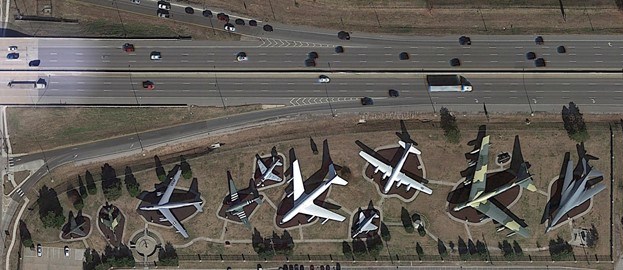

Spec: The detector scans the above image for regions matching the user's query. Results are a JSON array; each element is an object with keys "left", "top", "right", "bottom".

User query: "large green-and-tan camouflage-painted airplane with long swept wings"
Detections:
[{"left": 454, "top": 135, "right": 536, "bottom": 237}]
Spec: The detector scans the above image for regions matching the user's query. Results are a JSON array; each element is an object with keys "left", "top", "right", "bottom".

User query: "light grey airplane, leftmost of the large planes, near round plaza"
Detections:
[{"left": 140, "top": 165, "right": 203, "bottom": 238}]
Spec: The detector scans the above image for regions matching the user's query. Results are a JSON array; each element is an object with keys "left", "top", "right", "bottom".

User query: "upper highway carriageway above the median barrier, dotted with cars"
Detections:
[{"left": 0, "top": 36, "right": 623, "bottom": 71}]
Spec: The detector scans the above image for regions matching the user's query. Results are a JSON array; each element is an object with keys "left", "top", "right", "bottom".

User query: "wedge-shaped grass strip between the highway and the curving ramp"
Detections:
[{"left": 7, "top": 105, "right": 260, "bottom": 153}]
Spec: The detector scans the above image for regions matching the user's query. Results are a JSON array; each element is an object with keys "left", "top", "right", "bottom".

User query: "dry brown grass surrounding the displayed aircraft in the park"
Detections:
[{"left": 15, "top": 112, "right": 623, "bottom": 266}]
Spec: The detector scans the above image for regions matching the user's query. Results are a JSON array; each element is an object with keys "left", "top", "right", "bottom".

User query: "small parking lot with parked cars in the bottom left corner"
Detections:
[{"left": 22, "top": 245, "right": 84, "bottom": 270}]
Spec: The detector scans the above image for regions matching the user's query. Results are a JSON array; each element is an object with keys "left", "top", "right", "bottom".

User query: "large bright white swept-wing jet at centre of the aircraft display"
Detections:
[{"left": 281, "top": 140, "right": 348, "bottom": 224}]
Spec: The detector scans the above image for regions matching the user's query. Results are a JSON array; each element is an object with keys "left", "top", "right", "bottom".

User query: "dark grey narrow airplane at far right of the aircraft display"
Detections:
[{"left": 541, "top": 143, "right": 606, "bottom": 233}]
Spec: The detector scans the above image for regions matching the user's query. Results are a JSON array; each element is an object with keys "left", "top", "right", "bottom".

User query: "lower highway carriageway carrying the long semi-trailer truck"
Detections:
[{"left": 0, "top": 72, "right": 623, "bottom": 106}]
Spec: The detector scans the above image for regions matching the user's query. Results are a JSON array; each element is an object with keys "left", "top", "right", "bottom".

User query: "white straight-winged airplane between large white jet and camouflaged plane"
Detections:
[{"left": 357, "top": 121, "right": 433, "bottom": 194}]
